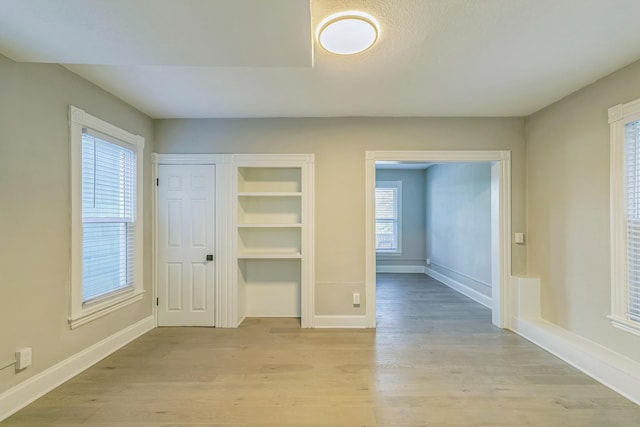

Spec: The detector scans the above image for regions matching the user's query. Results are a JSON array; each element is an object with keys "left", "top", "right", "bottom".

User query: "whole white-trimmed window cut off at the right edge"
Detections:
[{"left": 609, "top": 100, "right": 640, "bottom": 335}]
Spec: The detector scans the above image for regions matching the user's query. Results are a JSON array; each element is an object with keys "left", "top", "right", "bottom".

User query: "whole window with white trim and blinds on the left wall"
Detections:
[{"left": 70, "top": 107, "right": 144, "bottom": 328}]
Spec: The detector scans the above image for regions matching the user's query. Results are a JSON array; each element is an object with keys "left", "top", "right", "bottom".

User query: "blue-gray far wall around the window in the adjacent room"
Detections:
[{"left": 376, "top": 169, "right": 426, "bottom": 267}]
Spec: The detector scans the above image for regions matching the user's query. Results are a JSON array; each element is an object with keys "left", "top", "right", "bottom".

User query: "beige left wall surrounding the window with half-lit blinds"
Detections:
[{"left": 0, "top": 56, "right": 153, "bottom": 393}]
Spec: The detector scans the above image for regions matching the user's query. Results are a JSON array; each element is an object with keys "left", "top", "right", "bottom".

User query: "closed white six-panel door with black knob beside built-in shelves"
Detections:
[{"left": 157, "top": 165, "right": 215, "bottom": 326}]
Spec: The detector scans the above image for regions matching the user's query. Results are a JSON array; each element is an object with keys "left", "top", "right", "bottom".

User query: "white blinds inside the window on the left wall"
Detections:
[{"left": 82, "top": 129, "right": 136, "bottom": 303}]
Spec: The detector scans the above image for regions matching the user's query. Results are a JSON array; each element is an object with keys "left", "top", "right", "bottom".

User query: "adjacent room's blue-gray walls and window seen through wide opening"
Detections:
[{"left": 376, "top": 161, "right": 500, "bottom": 317}]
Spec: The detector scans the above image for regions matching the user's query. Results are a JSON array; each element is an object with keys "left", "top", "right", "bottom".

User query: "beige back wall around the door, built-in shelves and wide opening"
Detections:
[{"left": 154, "top": 118, "right": 525, "bottom": 315}]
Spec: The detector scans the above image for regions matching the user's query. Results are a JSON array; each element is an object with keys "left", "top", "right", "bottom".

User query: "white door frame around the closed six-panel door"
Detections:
[{"left": 151, "top": 153, "right": 230, "bottom": 327}]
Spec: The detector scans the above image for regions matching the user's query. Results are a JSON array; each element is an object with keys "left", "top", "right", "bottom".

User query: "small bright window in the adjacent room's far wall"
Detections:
[{"left": 376, "top": 181, "right": 402, "bottom": 255}]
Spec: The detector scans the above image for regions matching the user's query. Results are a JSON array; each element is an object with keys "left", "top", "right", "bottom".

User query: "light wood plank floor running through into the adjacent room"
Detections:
[{"left": 2, "top": 274, "right": 640, "bottom": 427}]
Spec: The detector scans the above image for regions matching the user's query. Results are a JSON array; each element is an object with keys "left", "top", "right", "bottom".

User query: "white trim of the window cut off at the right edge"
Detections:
[{"left": 608, "top": 99, "right": 640, "bottom": 335}]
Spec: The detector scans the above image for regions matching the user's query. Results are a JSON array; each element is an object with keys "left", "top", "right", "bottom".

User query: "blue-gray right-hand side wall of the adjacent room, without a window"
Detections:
[{"left": 426, "top": 163, "right": 491, "bottom": 297}]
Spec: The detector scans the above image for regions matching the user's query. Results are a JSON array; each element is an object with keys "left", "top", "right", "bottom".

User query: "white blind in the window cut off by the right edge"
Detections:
[{"left": 624, "top": 121, "right": 640, "bottom": 322}]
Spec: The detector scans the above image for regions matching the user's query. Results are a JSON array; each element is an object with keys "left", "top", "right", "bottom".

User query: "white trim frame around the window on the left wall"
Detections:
[{"left": 68, "top": 105, "right": 145, "bottom": 329}]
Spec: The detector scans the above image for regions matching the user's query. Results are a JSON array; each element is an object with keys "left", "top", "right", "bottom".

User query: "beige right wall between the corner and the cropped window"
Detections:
[{"left": 514, "top": 58, "right": 640, "bottom": 361}]
